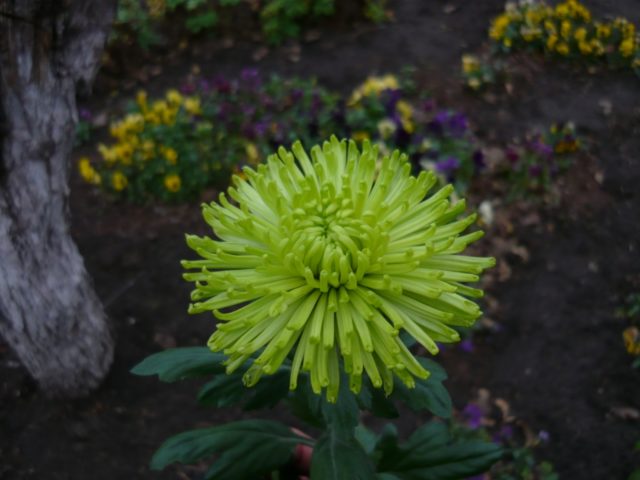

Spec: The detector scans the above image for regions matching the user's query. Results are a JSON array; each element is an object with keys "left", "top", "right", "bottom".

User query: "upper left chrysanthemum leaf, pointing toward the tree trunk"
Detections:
[{"left": 131, "top": 347, "right": 225, "bottom": 382}]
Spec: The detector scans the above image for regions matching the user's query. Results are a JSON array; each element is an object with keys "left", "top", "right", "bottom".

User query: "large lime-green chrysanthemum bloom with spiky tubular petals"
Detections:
[{"left": 183, "top": 137, "right": 495, "bottom": 401}]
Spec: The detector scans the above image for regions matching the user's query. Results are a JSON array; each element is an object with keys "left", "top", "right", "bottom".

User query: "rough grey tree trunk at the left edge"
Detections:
[{"left": 0, "top": 0, "right": 115, "bottom": 396}]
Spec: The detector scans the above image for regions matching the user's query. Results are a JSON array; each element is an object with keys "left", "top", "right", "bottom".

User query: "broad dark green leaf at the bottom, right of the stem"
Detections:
[{"left": 376, "top": 422, "right": 502, "bottom": 480}]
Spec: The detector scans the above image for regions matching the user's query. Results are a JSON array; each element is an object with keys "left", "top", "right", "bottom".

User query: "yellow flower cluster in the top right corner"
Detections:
[{"left": 489, "top": 0, "right": 640, "bottom": 74}]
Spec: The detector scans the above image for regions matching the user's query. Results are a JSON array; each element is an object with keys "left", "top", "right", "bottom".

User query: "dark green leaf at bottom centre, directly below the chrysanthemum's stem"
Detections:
[{"left": 311, "top": 426, "right": 375, "bottom": 480}]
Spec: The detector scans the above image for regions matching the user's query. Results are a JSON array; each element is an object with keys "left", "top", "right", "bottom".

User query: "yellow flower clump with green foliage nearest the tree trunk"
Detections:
[{"left": 79, "top": 90, "right": 219, "bottom": 201}]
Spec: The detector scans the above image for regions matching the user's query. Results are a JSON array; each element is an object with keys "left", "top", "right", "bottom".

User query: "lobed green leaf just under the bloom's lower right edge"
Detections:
[{"left": 391, "top": 358, "right": 452, "bottom": 418}]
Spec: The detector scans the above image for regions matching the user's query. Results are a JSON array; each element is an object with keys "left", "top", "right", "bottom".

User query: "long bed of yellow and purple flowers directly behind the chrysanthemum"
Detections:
[{"left": 80, "top": 69, "right": 482, "bottom": 201}]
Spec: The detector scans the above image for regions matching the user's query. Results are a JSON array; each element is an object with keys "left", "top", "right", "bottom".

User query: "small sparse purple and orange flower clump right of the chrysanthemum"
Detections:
[{"left": 503, "top": 123, "right": 582, "bottom": 197}]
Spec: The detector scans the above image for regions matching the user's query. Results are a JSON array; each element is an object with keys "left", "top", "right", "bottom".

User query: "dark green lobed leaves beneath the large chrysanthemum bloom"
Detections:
[{"left": 132, "top": 347, "right": 501, "bottom": 480}]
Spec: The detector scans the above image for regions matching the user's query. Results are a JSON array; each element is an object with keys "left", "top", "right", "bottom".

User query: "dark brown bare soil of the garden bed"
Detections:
[{"left": 0, "top": 0, "right": 640, "bottom": 480}]
